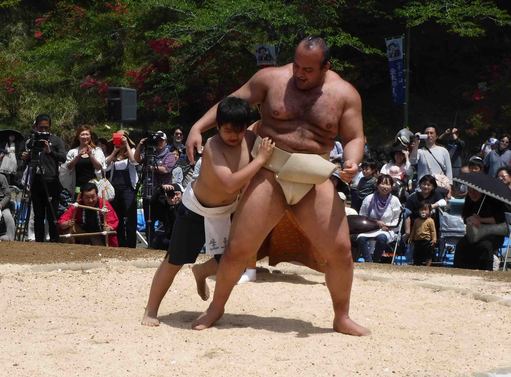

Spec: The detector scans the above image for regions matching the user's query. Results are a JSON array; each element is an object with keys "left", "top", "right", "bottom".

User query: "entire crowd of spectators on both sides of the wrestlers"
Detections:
[{"left": 0, "top": 114, "right": 511, "bottom": 270}]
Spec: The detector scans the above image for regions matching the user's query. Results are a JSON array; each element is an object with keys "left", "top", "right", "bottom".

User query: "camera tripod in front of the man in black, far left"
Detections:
[{"left": 14, "top": 149, "right": 56, "bottom": 241}]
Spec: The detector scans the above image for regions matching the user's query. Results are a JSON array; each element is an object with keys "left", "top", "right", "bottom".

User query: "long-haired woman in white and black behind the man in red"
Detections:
[{"left": 61, "top": 125, "right": 106, "bottom": 197}]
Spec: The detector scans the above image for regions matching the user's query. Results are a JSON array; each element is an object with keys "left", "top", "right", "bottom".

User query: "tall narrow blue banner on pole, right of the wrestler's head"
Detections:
[{"left": 385, "top": 36, "right": 406, "bottom": 105}]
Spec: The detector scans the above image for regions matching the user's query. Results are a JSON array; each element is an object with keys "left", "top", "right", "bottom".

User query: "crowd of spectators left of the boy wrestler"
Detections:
[{"left": 0, "top": 114, "right": 193, "bottom": 248}]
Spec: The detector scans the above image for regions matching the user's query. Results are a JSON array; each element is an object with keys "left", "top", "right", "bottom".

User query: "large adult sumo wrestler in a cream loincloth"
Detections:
[{"left": 186, "top": 37, "right": 370, "bottom": 335}]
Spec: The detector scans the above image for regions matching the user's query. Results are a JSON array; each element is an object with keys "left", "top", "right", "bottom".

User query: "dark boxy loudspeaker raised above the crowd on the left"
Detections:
[{"left": 107, "top": 87, "right": 137, "bottom": 122}]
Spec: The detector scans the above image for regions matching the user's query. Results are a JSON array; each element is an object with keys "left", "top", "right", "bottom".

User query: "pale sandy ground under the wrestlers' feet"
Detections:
[{"left": 0, "top": 242, "right": 511, "bottom": 377}]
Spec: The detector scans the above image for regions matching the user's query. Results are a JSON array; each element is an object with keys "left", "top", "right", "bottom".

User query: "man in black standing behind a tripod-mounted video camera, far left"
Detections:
[{"left": 21, "top": 114, "right": 66, "bottom": 242}]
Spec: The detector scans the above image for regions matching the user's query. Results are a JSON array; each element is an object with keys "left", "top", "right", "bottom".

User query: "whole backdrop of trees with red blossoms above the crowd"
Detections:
[{"left": 0, "top": 0, "right": 511, "bottom": 148}]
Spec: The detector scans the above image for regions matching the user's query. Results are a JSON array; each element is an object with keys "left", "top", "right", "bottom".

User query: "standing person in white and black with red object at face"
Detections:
[{"left": 106, "top": 130, "right": 138, "bottom": 248}]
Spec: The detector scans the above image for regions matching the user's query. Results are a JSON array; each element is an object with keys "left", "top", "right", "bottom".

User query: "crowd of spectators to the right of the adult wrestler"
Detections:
[{"left": 330, "top": 124, "right": 511, "bottom": 270}]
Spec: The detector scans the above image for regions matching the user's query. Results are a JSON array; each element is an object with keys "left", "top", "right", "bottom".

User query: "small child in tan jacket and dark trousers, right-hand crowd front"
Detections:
[{"left": 410, "top": 202, "right": 437, "bottom": 266}]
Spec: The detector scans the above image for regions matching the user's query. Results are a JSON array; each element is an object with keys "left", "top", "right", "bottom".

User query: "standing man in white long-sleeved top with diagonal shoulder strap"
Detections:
[{"left": 410, "top": 124, "right": 452, "bottom": 189}]
